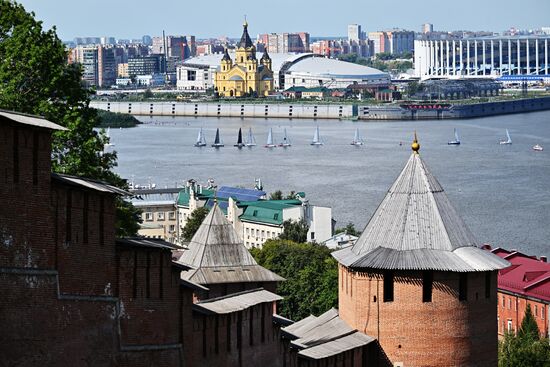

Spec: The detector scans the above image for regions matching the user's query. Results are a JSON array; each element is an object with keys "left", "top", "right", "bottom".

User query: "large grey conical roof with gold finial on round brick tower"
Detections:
[{"left": 333, "top": 140, "right": 509, "bottom": 272}]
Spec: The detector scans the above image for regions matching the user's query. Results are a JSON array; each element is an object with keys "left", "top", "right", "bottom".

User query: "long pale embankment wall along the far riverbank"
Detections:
[{"left": 90, "top": 97, "right": 550, "bottom": 120}]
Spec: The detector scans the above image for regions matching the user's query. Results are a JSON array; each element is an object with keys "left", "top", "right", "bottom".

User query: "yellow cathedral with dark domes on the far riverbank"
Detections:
[{"left": 214, "top": 21, "right": 273, "bottom": 97}]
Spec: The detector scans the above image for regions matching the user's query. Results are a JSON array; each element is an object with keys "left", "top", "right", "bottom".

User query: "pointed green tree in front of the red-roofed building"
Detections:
[{"left": 498, "top": 305, "right": 550, "bottom": 367}]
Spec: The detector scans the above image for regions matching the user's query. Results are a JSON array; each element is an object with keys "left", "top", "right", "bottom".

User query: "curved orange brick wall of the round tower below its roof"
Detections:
[{"left": 339, "top": 266, "right": 497, "bottom": 367}]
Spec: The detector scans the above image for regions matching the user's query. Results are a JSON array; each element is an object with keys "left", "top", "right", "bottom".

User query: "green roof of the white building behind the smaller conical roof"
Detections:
[{"left": 239, "top": 200, "right": 302, "bottom": 225}]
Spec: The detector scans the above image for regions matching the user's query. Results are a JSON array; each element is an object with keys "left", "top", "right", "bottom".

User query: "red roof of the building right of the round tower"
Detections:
[{"left": 484, "top": 245, "right": 550, "bottom": 302}]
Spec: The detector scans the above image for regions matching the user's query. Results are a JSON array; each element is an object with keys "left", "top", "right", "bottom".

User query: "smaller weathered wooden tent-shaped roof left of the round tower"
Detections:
[{"left": 177, "top": 203, "right": 284, "bottom": 284}]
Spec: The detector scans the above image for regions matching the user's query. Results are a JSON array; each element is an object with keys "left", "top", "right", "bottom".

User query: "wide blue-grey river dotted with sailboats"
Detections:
[{"left": 106, "top": 111, "right": 550, "bottom": 256}]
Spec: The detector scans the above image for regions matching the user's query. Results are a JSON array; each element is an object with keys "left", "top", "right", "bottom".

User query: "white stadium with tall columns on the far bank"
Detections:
[{"left": 414, "top": 35, "right": 550, "bottom": 79}]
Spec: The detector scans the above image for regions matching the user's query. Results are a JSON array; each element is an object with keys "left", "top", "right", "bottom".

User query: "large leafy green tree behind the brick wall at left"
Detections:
[{"left": 0, "top": 0, "right": 139, "bottom": 235}]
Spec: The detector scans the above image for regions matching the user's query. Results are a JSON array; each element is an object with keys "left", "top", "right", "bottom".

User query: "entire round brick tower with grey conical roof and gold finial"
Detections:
[{"left": 333, "top": 138, "right": 509, "bottom": 367}]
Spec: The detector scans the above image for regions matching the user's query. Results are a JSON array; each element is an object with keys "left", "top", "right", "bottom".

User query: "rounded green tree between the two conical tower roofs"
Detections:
[{"left": 251, "top": 240, "right": 338, "bottom": 320}]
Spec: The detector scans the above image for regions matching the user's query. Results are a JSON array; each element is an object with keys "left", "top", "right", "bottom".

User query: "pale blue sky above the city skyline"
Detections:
[{"left": 18, "top": 0, "right": 550, "bottom": 40}]
